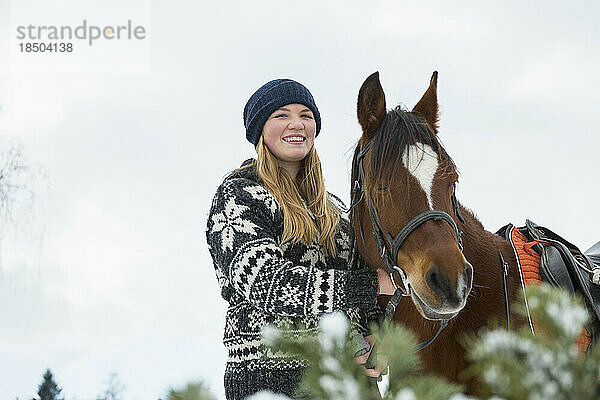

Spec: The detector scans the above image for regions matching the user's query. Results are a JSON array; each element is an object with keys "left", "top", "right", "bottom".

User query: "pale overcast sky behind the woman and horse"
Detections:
[{"left": 0, "top": 0, "right": 600, "bottom": 400}]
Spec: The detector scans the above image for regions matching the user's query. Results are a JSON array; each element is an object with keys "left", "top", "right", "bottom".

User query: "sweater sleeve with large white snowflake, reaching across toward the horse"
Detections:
[{"left": 206, "top": 178, "right": 377, "bottom": 317}]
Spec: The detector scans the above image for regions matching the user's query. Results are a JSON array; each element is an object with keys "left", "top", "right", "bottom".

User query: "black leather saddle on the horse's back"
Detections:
[{"left": 496, "top": 220, "right": 600, "bottom": 343}]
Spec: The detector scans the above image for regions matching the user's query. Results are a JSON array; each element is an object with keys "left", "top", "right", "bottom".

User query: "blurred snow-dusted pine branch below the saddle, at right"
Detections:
[{"left": 467, "top": 285, "right": 600, "bottom": 400}]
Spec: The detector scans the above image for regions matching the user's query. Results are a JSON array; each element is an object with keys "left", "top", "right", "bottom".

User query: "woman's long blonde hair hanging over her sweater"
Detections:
[{"left": 234, "top": 135, "right": 340, "bottom": 257}]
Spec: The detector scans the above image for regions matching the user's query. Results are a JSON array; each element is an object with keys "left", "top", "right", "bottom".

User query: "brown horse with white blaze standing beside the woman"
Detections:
[{"left": 350, "top": 72, "right": 596, "bottom": 393}]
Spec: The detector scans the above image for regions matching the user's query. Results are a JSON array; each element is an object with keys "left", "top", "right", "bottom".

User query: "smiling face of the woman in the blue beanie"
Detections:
[{"left": 262, "top": 104, "right": 316, "bottom": 166}]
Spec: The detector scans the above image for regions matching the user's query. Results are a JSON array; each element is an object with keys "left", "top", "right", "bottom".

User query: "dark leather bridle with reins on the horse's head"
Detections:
[{"left": 350, "top": 141, "right": 465, "bottom": 360}]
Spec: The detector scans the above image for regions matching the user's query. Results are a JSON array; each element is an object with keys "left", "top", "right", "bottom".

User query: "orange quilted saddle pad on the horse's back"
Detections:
[{"left": 511, "top": 228, "right": 592, "bottom": 352}]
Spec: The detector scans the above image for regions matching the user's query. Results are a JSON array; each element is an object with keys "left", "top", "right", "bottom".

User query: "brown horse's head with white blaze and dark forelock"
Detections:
[{"left": 352, "top": 72, "right": 473, "bottom": 320}]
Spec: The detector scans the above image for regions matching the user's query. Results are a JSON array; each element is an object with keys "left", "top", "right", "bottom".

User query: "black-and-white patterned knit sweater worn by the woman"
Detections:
[{"left": 206, "top": 160, "right": 381, "bottom": 400}]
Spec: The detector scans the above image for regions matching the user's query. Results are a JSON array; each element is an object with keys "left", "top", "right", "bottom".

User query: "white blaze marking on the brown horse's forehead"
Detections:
[{"left": 402, "top": 143, "right": 438, "bottom": 210}]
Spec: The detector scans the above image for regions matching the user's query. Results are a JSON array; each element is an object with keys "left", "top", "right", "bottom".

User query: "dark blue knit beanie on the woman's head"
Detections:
[{"left": 244, "top": 79, "right": 321, "bottom": 146}]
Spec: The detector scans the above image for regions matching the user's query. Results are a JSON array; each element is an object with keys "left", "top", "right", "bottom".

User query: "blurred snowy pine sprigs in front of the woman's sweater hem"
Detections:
[{"left": 252, "top": 312, "right": 464, "bottom": 400}]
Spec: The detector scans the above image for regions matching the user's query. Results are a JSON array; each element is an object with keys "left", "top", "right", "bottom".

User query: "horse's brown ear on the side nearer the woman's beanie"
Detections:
[{"left": 356, "top": 72, "right": 386, "bottom": 141}]
